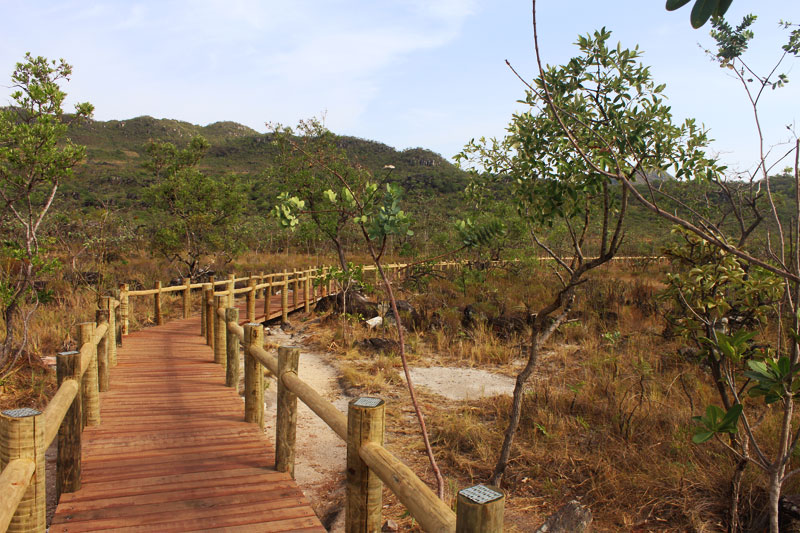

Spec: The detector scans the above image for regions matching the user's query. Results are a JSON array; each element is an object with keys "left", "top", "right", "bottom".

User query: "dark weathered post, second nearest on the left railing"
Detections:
[{"left": 56, "top": 352, "right": 83, "bottom": 494}]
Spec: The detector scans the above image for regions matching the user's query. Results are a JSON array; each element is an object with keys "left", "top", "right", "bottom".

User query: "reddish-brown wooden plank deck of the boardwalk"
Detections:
[{"left": 49, "top": 295, "right": 325, "bottom": 533}]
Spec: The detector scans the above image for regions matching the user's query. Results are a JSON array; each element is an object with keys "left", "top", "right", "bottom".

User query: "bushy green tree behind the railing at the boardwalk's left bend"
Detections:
[{"left": 147, "top": 137, "right": 245, "bottom": 277}]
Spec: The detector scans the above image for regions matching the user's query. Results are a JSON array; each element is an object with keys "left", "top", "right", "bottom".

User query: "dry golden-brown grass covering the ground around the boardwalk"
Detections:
[{"left": 0, "top": 255, "right": 798, "bottom": 531}]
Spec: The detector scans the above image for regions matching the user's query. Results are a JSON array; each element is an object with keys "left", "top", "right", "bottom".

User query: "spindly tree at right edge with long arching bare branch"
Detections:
[{"left": 533, "top": 4, "right": 800, "bottom": 533}]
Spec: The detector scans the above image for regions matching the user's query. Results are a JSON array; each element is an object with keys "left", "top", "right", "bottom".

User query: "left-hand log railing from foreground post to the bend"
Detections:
[{"left": 0, "top": 297, "right": 119, "bottom": 533}]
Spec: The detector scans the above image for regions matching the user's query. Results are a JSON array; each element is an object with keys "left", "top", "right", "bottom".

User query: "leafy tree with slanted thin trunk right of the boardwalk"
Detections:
[{"left": 458, "top": 23, "right": 714, "bottom": 483}]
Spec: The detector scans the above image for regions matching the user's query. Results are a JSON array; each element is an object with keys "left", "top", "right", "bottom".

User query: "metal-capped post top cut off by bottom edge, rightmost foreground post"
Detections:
[{"left": 456, "top": 485, "right": 506, "bottom": 533}]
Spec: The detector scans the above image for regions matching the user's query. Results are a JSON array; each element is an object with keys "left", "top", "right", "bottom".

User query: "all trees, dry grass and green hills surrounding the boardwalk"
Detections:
[{"left": 0, "top": 6, "right": 800, "bottom": 532}]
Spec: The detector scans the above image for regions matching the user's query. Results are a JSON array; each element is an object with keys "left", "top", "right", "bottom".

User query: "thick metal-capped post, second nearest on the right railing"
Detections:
[{"left": 345, "top": 397, "right": 385, "bottom": 533}]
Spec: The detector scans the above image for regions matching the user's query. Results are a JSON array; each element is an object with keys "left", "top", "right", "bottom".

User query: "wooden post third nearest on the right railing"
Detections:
[{"left": 275, "top": 346, "right": 300, "bottom": 479}]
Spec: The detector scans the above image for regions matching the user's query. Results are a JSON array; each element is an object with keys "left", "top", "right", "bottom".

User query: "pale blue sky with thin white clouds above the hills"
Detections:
[{"left": 0, "top": 0, "right": 800, "bottom": 174}]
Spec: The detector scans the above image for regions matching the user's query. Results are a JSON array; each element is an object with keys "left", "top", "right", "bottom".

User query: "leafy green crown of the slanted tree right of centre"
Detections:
[{"left": 457, "top": 29, "right": 722, "bottom": 237}]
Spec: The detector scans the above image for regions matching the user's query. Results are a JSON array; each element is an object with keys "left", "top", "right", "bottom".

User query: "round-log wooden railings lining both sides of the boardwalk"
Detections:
[{"left": 0, "top": 262, "right": 504, "bottom": 533}]
